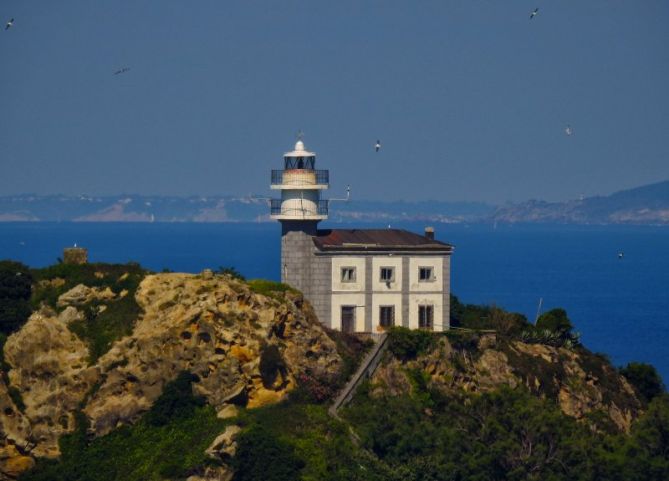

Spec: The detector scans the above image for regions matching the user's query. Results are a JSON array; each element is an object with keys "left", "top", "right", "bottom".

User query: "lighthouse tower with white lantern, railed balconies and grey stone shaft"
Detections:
[{"left": 270, "top": 140, "right": 329, "bottom": 288}]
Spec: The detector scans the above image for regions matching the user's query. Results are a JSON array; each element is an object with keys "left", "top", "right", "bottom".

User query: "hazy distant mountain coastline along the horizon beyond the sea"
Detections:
[{"left": 0, "top": 181, "right": 669, "bottom": 225}]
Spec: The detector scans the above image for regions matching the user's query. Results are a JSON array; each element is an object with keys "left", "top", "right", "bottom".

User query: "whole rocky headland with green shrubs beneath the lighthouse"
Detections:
[{"left": 0, "top": 265, "right": 669, "bottom": 481}]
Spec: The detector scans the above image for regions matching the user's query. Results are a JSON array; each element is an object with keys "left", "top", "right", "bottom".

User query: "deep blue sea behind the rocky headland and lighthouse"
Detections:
[{"left": 0, "top": 223, "right": 669, "bottom": 382}]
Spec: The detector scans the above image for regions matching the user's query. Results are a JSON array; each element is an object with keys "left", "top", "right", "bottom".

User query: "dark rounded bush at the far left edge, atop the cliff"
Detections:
[{"left": 0, "top": 261, "right": 33, "bottom": 334}]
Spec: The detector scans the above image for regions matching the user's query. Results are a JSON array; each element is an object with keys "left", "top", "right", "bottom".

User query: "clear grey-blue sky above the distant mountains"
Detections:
[{"left": 0, "top": 0, "right": 669, "bottom": 203}]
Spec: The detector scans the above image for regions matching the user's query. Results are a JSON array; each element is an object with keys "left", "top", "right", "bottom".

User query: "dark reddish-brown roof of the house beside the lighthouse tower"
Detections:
[{"left": 313, "top": 229, "right": 453, "bottom": 252}]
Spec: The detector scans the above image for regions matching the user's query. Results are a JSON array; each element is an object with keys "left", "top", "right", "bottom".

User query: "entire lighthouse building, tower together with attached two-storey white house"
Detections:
[{"left": 271, "top": 141, "right": 453, "bottom": 332}]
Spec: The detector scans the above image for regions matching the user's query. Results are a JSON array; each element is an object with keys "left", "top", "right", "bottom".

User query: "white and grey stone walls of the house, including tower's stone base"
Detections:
[{"left": 281, "top": 227, "right": 450, "bottom": 332}]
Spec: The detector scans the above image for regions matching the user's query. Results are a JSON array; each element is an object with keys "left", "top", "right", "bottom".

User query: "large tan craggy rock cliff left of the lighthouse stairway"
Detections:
[{"left": 0, "top": 273, "right": 342, "bottom": 479}]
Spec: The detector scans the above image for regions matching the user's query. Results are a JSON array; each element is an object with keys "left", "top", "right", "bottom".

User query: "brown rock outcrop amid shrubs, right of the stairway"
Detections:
[{"left": 372, "top": 337, "right": 641, "bottom": 431}]
